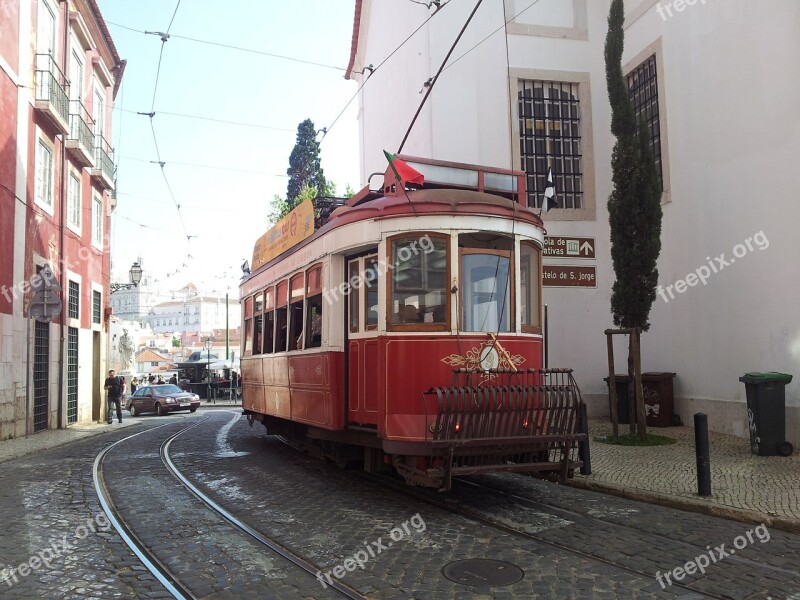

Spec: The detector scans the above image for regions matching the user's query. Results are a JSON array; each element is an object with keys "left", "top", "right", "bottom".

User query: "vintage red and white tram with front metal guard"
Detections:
[{"left": 240, "top": 156, "right": 586, "bottom": 489}]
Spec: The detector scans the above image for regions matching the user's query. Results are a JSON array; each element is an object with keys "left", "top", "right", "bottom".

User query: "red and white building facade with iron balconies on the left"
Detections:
[{"left": 0, "top": 0, "right": 125, "bottom": 440}]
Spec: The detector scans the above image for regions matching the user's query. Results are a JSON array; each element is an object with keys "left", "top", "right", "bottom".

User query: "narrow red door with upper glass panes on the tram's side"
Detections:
[{"left": 347, "top": 254, "right": 379, "bottom": 425}]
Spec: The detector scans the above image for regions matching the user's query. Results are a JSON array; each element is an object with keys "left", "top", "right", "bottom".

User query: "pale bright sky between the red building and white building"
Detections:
[{"left": 98, "top": 0, "right": 361, "bottom": 297}]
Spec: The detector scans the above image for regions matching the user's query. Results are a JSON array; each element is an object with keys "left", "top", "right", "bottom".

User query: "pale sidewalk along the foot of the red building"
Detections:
[{"left": 0, "top": 400, "right": 242, "bottom": 463}]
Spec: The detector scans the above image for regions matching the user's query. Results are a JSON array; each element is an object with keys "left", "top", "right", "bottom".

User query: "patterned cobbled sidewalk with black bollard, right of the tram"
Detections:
[{"left": 568, "top": 419, "right": 800, "bottom": 533}]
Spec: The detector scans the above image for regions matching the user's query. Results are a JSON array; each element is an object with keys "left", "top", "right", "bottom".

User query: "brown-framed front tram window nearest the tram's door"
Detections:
[{"left": 389, "top": 234, "right": 450, "bottom": 331}]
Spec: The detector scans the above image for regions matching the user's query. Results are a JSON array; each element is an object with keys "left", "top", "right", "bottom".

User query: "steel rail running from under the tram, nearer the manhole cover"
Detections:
[{"left": 366, "top": 473, "right": 730, "bottom": 600}]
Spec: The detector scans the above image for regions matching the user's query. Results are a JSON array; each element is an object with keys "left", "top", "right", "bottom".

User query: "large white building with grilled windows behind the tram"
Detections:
[{"left": 348, "top": 0, "right": 800, "bottom": 445}]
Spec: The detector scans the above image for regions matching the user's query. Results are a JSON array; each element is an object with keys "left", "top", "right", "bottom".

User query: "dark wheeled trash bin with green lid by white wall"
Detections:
[{"left": 739, "top": 373, "right": 794, "bottom": 456}]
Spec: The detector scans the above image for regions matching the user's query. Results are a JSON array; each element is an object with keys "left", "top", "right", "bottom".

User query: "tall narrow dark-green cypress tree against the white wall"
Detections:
[{"left": 605, "top": 0, "right": 661, "bottom": 437}]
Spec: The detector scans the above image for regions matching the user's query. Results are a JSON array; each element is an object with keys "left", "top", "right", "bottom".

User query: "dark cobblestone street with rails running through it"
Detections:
[{"left": 0, "top": 409, "right": 800, "bottom": 600}]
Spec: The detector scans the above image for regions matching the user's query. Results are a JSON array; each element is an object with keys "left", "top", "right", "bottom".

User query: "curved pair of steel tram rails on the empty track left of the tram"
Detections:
[{"left": 93, "top": 417, "right": 366, "bottom": 600}]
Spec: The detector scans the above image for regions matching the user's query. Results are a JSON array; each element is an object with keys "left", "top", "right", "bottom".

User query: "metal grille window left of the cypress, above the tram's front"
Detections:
[{"left": 517, "top": 80, "right": 583, "bottom": 208}]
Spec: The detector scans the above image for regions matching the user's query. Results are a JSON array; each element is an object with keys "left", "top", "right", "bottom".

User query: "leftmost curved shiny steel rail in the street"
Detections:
[{"left": 92, "top": 417, "right": 200, "bottom": 600}]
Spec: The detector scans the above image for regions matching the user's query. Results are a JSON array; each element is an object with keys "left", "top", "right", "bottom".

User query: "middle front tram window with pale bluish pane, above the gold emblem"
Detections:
[{"left": 459, "top": 248, "right": 513, "bottom": 333}]
